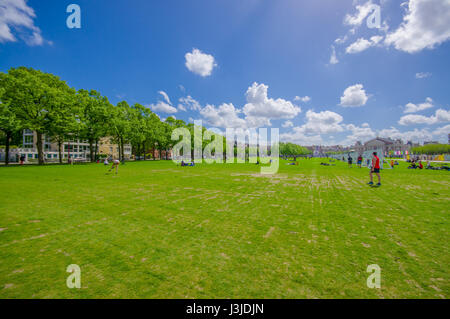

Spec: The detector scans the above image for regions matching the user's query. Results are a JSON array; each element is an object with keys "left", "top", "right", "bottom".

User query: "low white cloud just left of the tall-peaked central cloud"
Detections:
[{"left": 200, "top": 103, "right": 247, "bottom": 128}]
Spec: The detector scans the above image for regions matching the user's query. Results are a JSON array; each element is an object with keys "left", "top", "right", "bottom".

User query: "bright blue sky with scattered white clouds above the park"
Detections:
[{"left": 0, "top": 0, "right": 450, "bottom": 145}]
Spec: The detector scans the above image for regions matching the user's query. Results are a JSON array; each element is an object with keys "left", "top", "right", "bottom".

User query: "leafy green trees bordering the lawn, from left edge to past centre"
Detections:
[{"left": 0, "top": 67, "right": 309, "bottom": 164}]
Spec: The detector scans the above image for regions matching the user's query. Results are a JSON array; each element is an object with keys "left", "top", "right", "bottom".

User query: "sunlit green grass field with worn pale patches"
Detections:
[{"left": 0, "top": 160, "right": 450, "bottom": 298}]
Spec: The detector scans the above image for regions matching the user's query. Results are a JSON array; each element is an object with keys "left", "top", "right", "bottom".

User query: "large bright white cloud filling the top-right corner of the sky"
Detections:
[{"left": 385, "top": 0, "right": 450, "bottom": 53}]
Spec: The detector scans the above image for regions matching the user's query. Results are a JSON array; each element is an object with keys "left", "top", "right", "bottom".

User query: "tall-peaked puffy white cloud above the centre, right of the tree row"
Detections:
[{"left": 243, "top": 82, "right": 301, "bottom": 127}]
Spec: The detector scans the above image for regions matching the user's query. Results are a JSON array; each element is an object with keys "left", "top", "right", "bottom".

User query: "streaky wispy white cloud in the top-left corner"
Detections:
[{"left": 0, "top": 0, "right": 44, "bottom": 45}]
